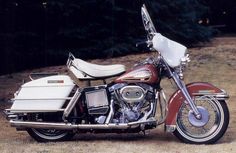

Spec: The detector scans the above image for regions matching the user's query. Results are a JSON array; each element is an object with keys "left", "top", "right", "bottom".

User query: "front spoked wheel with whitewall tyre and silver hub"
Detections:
[{"left": 174, "top": 96, "right": 229, "bottom": 144}]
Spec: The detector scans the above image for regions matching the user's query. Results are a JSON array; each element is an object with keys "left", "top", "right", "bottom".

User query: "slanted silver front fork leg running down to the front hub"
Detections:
[{"left": 172, "top": 72, "right": 202, "bottom": 119}]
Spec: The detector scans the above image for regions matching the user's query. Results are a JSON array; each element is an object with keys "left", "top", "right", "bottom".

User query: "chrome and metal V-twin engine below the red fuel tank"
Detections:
[{"left": 111, "top": 83, "right": 154, "bottom": 123}]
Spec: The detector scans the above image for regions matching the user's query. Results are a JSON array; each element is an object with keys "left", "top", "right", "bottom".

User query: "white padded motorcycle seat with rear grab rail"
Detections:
[{"left": 70, "top": 58, "right": 125, "bottom": 79}]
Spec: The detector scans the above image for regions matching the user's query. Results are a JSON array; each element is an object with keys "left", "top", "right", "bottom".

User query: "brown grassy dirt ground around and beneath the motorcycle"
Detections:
[{"left": 0, "top": 37, "right": 236, "bottom": 153}]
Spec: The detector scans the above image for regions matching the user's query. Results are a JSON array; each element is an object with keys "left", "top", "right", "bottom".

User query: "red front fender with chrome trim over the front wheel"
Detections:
[{"left": 165, "top": 82, "right": 229, "bottom": 132}]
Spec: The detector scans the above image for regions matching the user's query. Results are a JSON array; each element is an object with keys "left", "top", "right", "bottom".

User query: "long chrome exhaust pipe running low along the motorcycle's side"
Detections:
[{"left": 10, "top": 119, "right": 156, "bottom": 130}]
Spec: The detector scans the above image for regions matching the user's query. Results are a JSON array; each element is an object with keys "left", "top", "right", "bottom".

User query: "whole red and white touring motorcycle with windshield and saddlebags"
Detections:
[{"left": 5, "top": 5, "right": 229, "bottom": 144}]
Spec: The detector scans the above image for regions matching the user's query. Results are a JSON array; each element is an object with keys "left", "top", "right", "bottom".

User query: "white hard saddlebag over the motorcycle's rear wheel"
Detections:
[{"left": 11, "top": 75, "right": 75, "bottom": 111}]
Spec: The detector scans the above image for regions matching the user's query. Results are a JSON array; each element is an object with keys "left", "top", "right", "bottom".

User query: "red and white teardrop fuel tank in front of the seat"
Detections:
[{"left": 115, "top": 64, "right": 159, "bottom": 84}]
